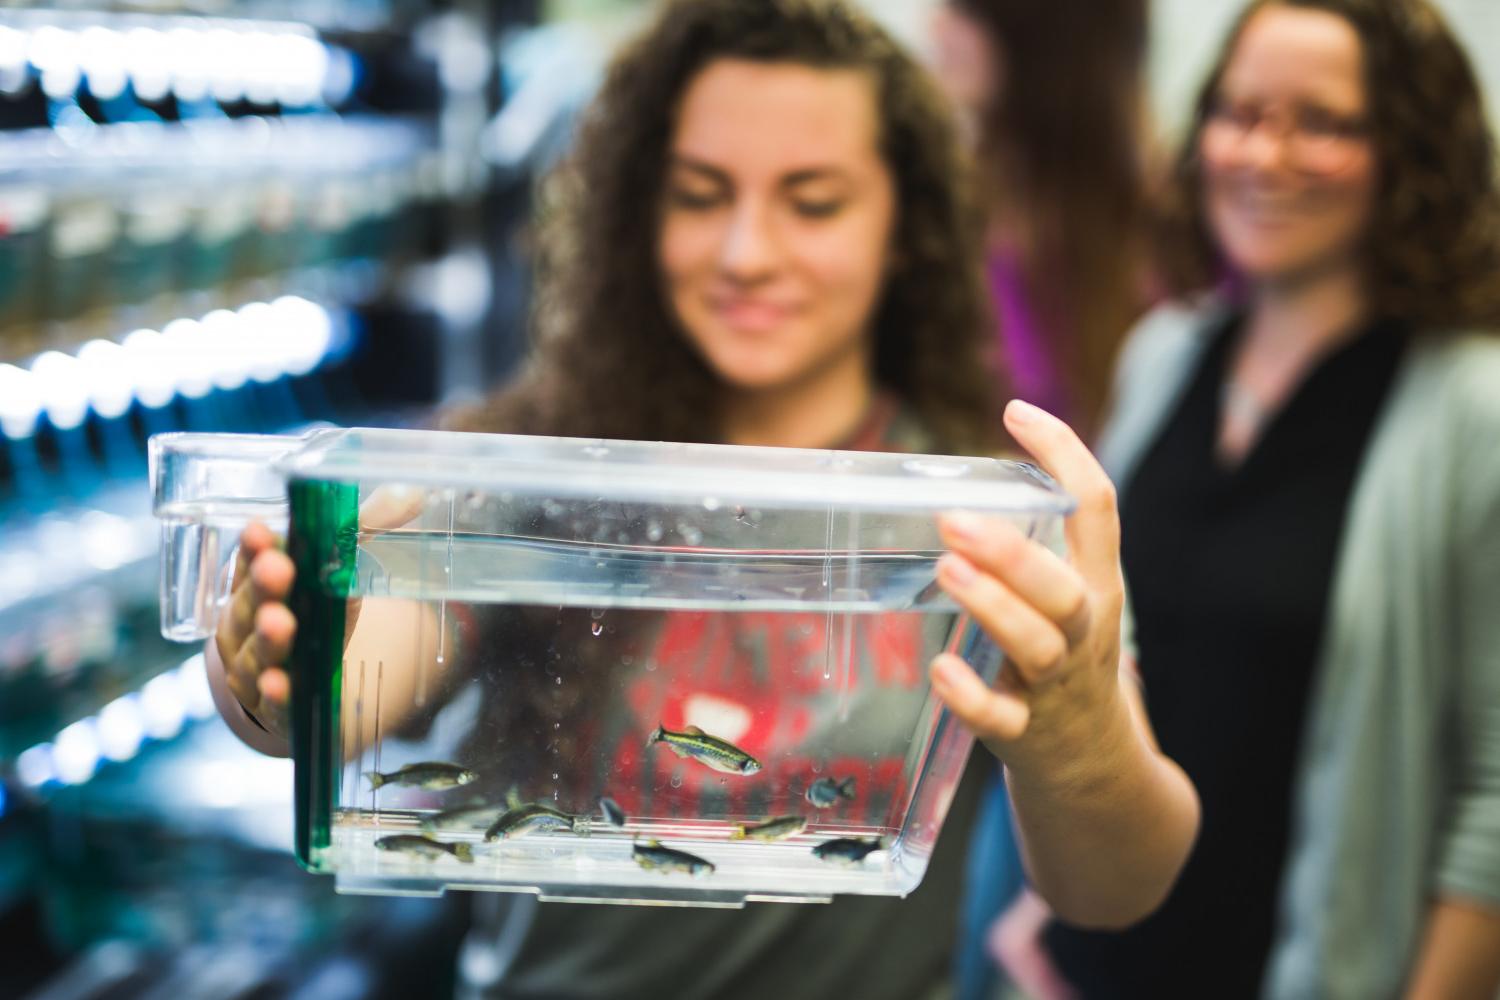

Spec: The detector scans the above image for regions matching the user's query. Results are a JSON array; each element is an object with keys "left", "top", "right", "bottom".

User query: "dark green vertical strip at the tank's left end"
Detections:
[{"left": 287, "top": 480, "right": 360, "bottom": 871}]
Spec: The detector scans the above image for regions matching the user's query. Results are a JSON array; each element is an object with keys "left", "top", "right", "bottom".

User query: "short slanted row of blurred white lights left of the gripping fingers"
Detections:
[{"left": 15, "top": 652, "right": 215, "bottom": 789}]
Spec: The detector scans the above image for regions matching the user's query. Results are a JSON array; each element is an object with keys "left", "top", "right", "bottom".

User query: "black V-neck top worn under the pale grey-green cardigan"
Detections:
[{"left": 1046, "top": 321, "right": 1406, "bottom": 997}]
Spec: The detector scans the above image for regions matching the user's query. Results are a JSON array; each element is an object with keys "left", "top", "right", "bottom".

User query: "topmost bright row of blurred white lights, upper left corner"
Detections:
[{"left": 0, "top": 21, "right": 357, "bottom": 108}]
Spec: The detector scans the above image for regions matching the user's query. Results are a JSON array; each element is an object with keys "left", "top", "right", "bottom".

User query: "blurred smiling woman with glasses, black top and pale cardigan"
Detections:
[{"left": 1026, "top": 0, "right": 1500, "bottom": 999}]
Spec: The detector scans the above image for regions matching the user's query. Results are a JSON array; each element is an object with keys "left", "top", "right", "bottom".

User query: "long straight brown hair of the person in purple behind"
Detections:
[{"left": 950, "top": 0, "right": 1148, "bottom": 432}]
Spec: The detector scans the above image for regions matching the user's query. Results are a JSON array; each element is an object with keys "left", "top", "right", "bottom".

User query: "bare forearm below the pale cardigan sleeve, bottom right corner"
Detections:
[{"left": 1406, "top": 900, "right": 1500, "bottom": 1000}]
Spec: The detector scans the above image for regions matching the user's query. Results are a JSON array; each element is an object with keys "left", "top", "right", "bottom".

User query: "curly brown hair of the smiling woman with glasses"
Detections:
[{"left": 1161, "top": 0, "right": 1500, "bottom": 330}]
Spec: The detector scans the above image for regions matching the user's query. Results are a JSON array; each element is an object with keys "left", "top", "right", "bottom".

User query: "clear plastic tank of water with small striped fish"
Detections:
[{"left": 152, "top": 429, "right": 1071, "bottom": 907}]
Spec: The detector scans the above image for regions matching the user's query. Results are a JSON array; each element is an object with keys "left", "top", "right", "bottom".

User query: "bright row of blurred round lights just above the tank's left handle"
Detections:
[{"left": 0, "top": 295, "right": 336, "bottom": 441}]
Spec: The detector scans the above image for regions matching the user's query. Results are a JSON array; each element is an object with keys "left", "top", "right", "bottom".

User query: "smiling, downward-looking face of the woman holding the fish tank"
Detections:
[{"left": 657, "top": 58, "right": 896, "bottom": 391}]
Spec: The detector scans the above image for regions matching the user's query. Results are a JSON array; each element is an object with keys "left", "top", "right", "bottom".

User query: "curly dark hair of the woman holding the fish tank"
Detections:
[{"left": 449, "top": 0, "right": 1005, "bottom": 451}]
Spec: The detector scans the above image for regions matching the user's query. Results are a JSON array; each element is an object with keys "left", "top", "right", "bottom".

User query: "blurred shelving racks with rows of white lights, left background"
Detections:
[{"left": 0, "top": 0, "right": 612, "bottom": 1000}]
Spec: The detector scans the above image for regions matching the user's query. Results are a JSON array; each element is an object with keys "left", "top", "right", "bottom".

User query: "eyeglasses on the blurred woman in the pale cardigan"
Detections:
[{"left": 1200, "top": 100, "right": 1370, "bottom": 174}]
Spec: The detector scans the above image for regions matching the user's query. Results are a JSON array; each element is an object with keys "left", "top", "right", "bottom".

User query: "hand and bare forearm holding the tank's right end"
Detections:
[{"left": 932, "top": 402, "right": 1199, "bottom": 928}]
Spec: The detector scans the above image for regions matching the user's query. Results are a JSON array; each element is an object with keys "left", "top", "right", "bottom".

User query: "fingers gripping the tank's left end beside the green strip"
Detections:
[{"left": 215, "top": 522, "right": 297, "bottom": 736}]
